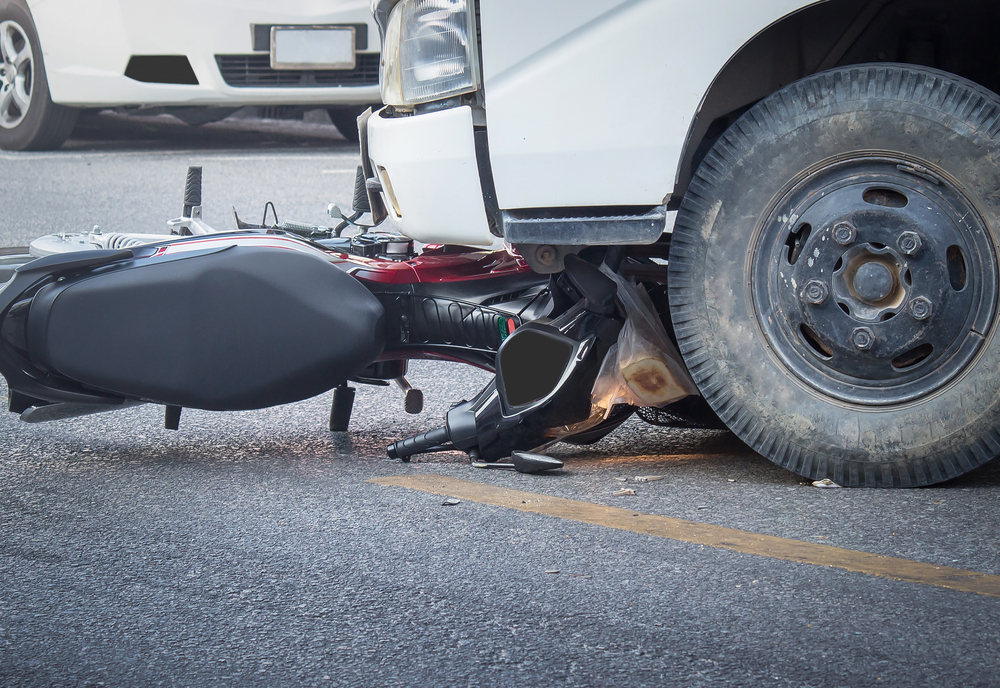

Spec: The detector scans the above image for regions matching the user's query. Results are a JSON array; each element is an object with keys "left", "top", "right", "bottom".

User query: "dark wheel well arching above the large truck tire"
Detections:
[{"left": 670, "top": 0, "right": 1000, "bottom": 207}]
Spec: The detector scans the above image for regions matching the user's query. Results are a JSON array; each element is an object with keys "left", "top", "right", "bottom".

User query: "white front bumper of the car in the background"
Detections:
[{"left": 28, "top": 0, "right": 381, "bottom": 107}]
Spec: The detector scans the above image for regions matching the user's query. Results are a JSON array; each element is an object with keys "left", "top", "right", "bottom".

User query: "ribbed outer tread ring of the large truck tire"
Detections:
[{"left": 668, "top": 64, "right": 1000, "bottom": 487}]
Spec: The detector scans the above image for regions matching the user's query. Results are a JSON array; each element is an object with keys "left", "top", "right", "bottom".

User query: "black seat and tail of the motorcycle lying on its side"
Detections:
[{"left": 0, "top": 242, "right": 385, "bottom": 410}]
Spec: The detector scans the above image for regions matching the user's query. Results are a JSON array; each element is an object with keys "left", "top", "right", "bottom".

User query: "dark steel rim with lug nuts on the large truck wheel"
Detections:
[{"left": 750, "top": 154, "right": 998, "bottom": 406}]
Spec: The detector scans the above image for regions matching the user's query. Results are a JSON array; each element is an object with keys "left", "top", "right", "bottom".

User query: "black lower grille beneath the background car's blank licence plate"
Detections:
[{"left": 215, "top": 53, "right": 379, "bottom": 88}]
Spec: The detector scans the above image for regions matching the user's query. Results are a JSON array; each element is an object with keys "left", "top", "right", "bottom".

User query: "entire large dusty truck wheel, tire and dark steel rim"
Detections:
[{"left": 668, "top": 64, "right": 1000, "bottom": 487}]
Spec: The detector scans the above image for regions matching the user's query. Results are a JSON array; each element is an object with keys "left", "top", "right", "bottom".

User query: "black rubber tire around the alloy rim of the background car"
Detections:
[{"left": 0, "top": 0, "right": 78, "bottom": 151}]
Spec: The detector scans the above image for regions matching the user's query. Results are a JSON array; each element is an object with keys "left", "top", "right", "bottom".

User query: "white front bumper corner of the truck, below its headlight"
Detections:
[{"left": 368, "top": 106, "right": 500, "bottom": 246}]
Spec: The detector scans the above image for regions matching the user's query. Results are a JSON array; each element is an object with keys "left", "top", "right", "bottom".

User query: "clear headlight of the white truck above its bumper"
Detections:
[{"left": 379, "top": 0, "right": 479, "bottom": 106}]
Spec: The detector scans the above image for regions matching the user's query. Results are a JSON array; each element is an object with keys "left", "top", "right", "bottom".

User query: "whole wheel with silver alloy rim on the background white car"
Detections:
[{"left": 0, "top": 0, "right": 77, "bottom": 151}]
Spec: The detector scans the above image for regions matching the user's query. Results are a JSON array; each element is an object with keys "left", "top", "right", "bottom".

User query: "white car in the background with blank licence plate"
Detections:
[{"left": 0, "top": 0, "right": 380, "bottom": 150}]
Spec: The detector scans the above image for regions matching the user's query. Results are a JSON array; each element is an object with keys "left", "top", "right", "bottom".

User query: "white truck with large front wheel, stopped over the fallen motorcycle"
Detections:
[{"left": 362, "top": 0, "right": 1000, "bottom": 486}]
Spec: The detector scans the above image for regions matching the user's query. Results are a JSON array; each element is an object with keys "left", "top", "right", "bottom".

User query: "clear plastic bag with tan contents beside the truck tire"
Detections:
[{"left": 591, "top": 266, "right": 698, "bottom": 418}]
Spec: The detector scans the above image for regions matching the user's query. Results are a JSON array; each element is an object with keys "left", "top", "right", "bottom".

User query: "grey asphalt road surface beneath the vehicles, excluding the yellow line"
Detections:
[{"left": 0, "top": 119, "right": 1000, "bottom": 686}]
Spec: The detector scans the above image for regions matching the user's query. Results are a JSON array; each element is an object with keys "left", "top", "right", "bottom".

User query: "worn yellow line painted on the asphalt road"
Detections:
[{"left": 370, "top": 475, "right": 1000, "bottom": 597}]
